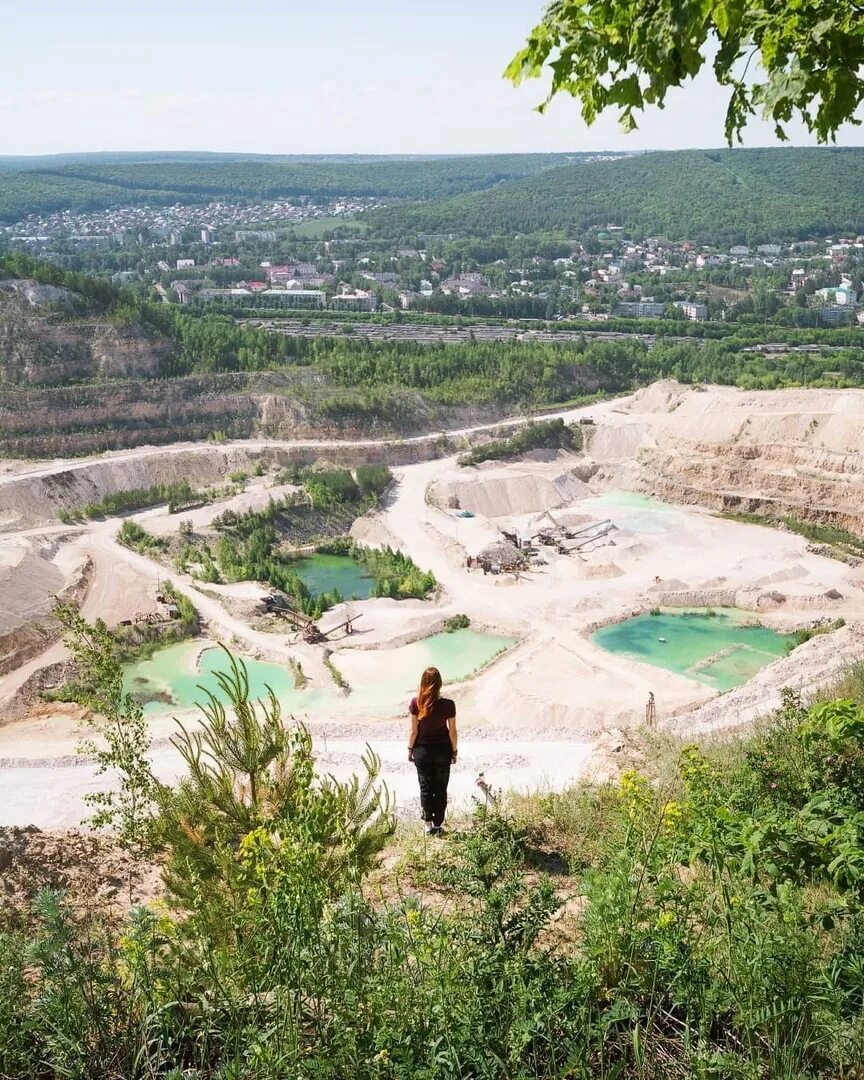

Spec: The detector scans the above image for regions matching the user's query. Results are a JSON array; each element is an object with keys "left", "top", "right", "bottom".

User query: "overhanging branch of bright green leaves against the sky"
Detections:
[{"left": 505, "top": 0, "right": 864, "bottom": 144}]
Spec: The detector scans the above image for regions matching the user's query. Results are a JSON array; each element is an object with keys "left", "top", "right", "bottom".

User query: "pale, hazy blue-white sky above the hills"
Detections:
[{"left": 6, "top": 0, "right": 864, "bottom": 156}]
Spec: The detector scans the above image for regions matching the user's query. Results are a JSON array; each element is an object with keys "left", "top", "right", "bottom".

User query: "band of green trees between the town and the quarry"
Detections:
[{"left": 0, "top": 255, "right": 864, "bottom": 414}]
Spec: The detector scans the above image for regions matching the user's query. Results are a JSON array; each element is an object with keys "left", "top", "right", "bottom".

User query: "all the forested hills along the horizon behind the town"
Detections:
[{"left": 0, "top": 147, "right": 864, "bottom": 244}]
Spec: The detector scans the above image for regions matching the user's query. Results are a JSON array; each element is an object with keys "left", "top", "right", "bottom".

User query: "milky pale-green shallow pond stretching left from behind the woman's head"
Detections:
[{"left": 124, "top": 630, "right": 515, "bottom": 715}]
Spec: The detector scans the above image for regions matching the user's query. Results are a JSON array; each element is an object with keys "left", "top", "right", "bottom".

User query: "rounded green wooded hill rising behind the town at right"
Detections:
[{"left": 369, "top": 148, "right": 864, "bottom": 243}]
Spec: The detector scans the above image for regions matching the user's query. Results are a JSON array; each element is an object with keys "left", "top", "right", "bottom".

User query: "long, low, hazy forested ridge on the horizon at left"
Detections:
[{"left": 0, "top": 152, "right": 596, "bottom": 222}]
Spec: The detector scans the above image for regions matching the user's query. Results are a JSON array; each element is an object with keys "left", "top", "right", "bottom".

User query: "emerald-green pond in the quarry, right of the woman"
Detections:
[{"left": 592, "top": 611, "right": 788, "bottom": 690}]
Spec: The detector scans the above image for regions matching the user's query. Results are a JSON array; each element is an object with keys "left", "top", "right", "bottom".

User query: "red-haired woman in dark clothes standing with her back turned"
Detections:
[{"left": 408, "top": 667, "right": 459, "bottom": 836}]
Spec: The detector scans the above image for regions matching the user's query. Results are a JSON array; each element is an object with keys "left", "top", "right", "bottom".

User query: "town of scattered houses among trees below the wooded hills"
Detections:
[{"left": 0, "top": 197, "right": 864, "bottom": 327}]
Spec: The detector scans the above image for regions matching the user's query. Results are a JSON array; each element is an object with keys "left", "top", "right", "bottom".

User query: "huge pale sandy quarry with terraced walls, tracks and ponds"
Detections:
[{"left": 0, "top": 381, "right": 864, "bottom": 827}]
